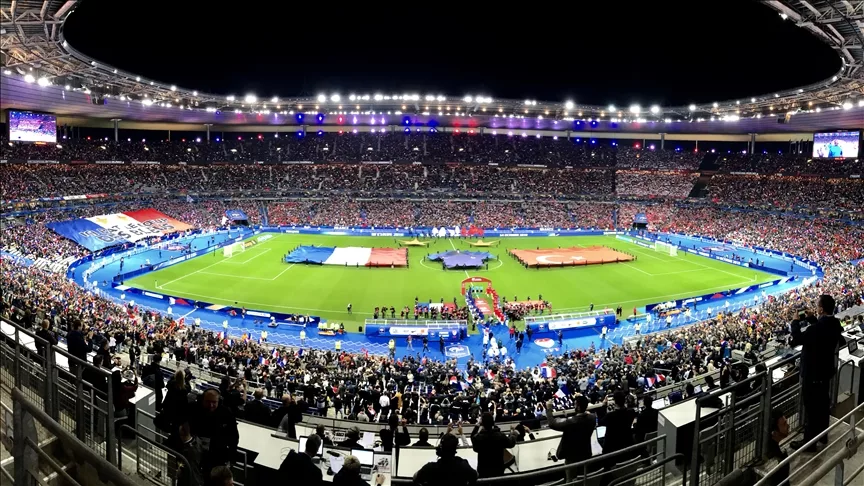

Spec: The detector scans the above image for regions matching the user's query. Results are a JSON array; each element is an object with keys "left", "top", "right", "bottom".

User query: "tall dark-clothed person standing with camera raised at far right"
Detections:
[{"left": 790, "top": 295, "right": 845, "bottom": 452}]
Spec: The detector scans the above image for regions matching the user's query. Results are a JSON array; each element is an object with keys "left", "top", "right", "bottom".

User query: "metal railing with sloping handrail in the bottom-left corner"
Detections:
[{"left": 2, "top": 387, "right": 135, "bottom": 486}]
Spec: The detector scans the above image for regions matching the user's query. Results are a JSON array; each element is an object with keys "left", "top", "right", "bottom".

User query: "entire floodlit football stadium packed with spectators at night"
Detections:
[{"left": 0, "top": 0, "right": 864, "bottom": 486}]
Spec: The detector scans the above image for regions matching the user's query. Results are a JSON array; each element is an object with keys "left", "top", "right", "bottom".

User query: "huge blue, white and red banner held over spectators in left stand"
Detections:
[{"left": 48, "top": 209, "right": 192, "bottom": 251}]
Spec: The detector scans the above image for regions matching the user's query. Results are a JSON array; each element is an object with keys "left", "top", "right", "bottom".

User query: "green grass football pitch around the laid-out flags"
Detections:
[{"left": 126, "top": 234, "right": 777, "bottom": 330}]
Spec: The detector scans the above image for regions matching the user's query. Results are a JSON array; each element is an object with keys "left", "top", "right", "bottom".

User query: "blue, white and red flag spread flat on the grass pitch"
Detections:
[{"left": 285, "top": 245, "right": 408, "bottom": 267}]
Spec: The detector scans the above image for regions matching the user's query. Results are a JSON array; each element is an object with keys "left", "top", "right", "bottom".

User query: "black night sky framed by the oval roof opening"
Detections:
[{"left": 65, "top": 0, "right": 840, "bottom": 106}]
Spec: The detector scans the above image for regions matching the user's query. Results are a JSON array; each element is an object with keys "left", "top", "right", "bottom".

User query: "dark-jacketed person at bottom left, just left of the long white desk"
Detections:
[{"left": 189, "top": 388, "right": 240, "bottom": 474}]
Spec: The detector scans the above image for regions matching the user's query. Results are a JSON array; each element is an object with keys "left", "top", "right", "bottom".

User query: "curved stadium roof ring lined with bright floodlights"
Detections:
[{"left": 0, "top": 0, "right": 864, "bottom": 127}]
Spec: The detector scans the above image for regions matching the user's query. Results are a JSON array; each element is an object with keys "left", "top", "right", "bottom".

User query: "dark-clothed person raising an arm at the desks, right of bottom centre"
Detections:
[{"left": 546, "top": 395, "right": 597, "bottom": 481}]
